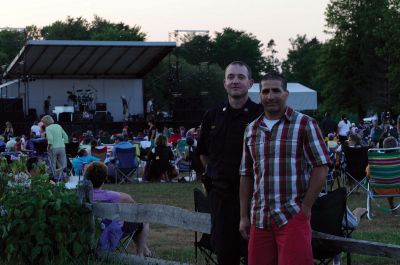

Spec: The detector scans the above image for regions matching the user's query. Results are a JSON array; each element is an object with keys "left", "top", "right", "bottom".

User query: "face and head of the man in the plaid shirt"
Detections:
[{"left": 260, "top": 80, "right": 289, "bottom": 119}]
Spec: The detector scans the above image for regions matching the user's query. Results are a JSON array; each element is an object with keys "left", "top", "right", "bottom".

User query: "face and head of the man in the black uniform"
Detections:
[{"left": 224, "top": 64, "right": 253, "bottom": 99}]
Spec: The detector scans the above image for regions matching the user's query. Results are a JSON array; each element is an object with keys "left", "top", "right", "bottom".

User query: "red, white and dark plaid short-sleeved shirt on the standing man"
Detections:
[{"left": 240, "top": 107, "right": 330, "bottom": 228}]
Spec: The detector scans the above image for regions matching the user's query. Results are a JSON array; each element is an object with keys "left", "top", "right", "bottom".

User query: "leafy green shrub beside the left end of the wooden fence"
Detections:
[{"left": 0, "top": 161, "right": 92, "bottom": 264}]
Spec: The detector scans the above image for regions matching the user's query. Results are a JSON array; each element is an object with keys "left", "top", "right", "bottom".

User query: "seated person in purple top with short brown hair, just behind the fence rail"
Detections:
[{"left": 85, "top": 162, "right": 151, "bottom": 257}]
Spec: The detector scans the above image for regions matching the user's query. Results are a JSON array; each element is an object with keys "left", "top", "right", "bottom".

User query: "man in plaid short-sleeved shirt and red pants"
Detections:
[{"left": 239, "top": 73, "right": 330, "bottom": 265}]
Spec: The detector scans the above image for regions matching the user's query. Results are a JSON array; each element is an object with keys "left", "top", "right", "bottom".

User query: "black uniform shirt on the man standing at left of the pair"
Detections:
[{"left": 198, "top": 99, "right": 262, "bottom": 193}]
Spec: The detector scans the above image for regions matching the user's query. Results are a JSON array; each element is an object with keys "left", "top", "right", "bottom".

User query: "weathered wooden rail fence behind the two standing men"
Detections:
[{"left": 88, "top": 203, "right": 400, "bottom": 265}]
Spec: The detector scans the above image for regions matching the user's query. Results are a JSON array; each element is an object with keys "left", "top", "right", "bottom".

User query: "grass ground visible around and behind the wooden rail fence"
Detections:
[{"left": 105, "top": 182, "right": 400, "bottom": 265}]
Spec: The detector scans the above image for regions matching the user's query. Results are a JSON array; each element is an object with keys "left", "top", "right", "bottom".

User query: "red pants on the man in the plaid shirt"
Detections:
[{"left": 248, "top": 211, "right": 313, "bottom": 265}]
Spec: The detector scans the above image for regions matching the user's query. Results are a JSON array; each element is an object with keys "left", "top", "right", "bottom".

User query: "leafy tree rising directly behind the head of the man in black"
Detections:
[{"left": 212, "top": 27, "right": 268, "bottom": 80}]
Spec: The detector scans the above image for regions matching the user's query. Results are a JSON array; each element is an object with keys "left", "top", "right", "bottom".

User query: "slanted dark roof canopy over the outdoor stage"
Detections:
[{"left": 4, "top": 40, "right": 176, "bottom": 79}]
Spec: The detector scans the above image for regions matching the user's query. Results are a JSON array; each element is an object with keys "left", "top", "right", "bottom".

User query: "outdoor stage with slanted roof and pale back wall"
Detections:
[{"left": 0, "top": 40, "right": 176, "bottom": 122}]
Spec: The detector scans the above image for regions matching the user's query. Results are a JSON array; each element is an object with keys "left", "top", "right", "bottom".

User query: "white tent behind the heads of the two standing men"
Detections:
[{"left": 249, "top": 83, "right": 317, "bottom": 110}]
